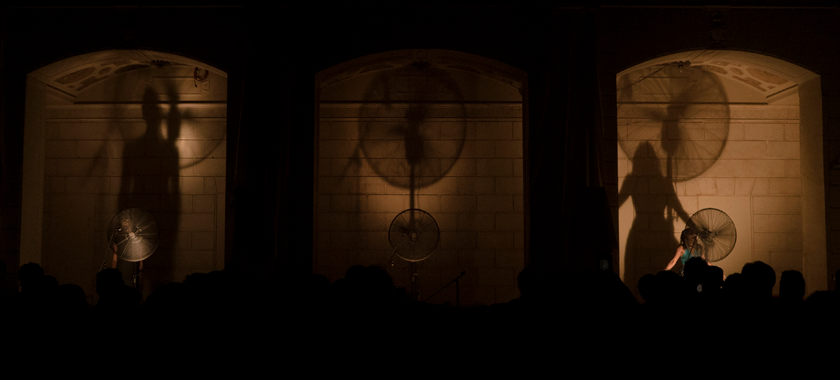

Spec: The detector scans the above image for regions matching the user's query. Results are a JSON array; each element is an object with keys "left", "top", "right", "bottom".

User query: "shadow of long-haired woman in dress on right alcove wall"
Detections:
[{"left": 618, "top": 142, "right": 689, "bottom": 302}]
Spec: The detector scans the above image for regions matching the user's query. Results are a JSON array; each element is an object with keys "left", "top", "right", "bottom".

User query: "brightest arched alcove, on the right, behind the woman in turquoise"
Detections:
[{"left": 616, "top": 50, "right": 826, "bottom": 296}]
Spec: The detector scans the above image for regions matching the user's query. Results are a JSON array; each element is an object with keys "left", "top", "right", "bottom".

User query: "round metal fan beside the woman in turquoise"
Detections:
[{"left": 686, "top": 208, "right": 738, "bottom": 263}]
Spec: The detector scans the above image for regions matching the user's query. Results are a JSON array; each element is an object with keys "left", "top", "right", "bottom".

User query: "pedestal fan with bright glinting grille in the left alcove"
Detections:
[{"left": 102, "top": 208, "right": 160, "bottom": 287}]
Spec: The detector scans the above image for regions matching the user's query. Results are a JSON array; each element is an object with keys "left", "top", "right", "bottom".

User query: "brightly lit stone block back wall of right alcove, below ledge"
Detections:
[{"left": 618, "top": 97, "right": 803, "bottom": 289}]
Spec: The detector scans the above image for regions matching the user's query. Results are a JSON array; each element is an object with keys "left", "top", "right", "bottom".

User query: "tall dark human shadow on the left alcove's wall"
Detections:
[{"left": 117, "top": 83, "right": 182, "bottom": 295}]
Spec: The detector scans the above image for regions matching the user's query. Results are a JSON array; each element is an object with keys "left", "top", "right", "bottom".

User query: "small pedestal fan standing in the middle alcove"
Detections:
[{"left": 388, "top": 208, "right": 440, "bottom": 301}]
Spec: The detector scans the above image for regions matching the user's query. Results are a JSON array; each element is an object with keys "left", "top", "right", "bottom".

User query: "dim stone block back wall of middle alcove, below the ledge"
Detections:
[{"left": 314, "top": 103, "right": 524, "bottom": 305}]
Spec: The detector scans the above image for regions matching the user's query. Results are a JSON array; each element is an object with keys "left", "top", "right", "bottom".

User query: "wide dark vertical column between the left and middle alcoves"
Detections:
[{"left": 230, "top": 5, "right": 314, "bottom": 279}]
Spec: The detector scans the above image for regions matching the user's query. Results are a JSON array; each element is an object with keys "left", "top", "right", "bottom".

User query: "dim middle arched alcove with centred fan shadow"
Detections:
[{"left": 313, "top": 50, "right": 525, "bottom": 305}]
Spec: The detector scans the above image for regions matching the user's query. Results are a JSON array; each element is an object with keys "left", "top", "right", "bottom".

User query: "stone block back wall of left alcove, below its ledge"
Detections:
[{"left": 43, "top": 104, "right": 226, "bottom": 295}]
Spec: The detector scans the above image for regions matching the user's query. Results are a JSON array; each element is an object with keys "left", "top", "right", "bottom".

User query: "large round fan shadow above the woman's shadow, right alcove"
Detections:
[{"left": 617, "top": 62, "right": 729, "bottom": 182}]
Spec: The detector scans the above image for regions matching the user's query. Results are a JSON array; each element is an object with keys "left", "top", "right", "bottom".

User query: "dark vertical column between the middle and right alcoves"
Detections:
[{"left": 527, "top": 9, "right": 614, "bottom": 272}]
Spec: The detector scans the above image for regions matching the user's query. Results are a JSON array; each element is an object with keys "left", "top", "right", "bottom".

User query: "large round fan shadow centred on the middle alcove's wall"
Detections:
[{"left": 359, "top": 66, "right": 467, "bottom": 191}]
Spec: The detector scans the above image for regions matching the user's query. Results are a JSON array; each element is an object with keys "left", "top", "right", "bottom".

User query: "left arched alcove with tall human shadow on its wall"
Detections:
[{"left": 20, "top": 50, "right": 227, "bottom": 296}]
